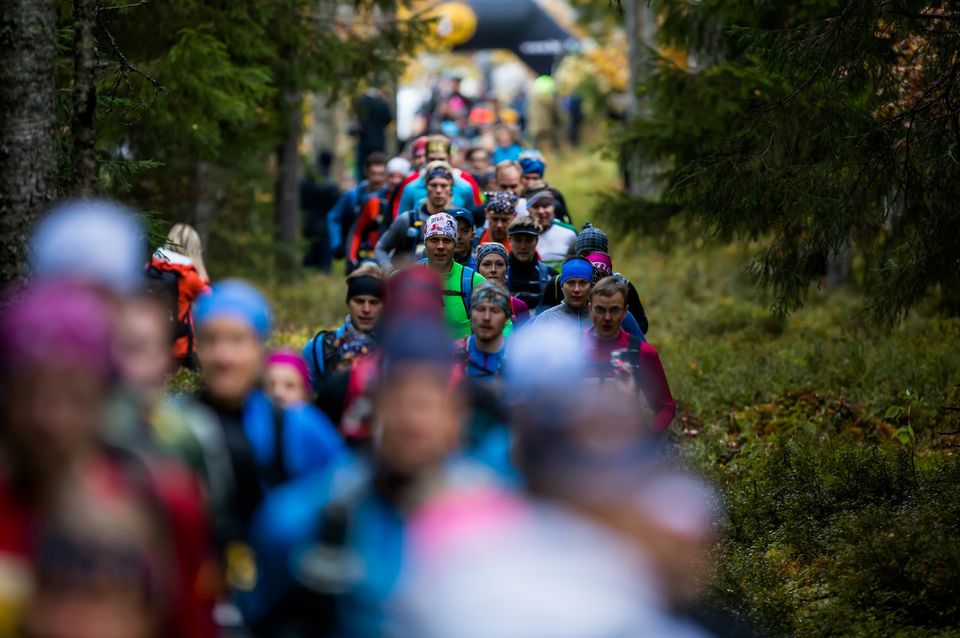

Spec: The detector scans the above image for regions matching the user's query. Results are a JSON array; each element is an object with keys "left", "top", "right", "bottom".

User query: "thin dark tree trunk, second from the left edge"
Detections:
[{"left": 70, "top": 0, "right": 97, "bottom": 196}]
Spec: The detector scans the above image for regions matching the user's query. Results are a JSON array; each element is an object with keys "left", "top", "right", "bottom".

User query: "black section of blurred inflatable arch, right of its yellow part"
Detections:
[{"left": 454, "top": 0, "right": 579, "bottom": 75}]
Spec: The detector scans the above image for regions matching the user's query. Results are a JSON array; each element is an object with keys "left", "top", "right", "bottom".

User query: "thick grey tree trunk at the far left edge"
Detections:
[{"left": 0, "top": 0, "right": 57, "bottom": 286}]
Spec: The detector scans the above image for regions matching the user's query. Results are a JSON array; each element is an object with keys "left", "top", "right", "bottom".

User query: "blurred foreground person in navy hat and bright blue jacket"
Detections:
[{"left": 242, "top": 280, "right": 478, "bottom": 636}]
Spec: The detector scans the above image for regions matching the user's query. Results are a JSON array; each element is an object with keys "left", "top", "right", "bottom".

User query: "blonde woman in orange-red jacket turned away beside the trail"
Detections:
[{"left": 147, "top": 224, "right": 210, "bottom": 368}]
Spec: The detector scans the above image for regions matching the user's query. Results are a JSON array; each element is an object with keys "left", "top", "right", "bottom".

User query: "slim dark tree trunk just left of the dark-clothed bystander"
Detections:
[{"left": 275, "top": 91, "right": 303, "bottom": 273}]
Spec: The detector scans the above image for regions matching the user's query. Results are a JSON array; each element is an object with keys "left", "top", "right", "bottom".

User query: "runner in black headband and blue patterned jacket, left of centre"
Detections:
[{"left": 300, "top": 264, "right": 384, "bottom": 389}]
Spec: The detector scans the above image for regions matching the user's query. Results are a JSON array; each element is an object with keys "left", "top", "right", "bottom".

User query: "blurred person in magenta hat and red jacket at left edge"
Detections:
[{"left": 0, "top": 281, "right": 215, "bottom": 638}]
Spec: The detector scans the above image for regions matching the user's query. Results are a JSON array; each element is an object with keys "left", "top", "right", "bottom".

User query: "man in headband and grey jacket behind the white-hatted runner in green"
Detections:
[{"left": 375, "top": 162, "right": 453, "bottom": 273}]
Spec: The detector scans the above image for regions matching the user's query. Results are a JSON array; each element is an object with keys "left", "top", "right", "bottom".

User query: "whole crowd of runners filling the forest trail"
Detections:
[{"left": 0, "top": 130, "right": 722, "bottom": 638}]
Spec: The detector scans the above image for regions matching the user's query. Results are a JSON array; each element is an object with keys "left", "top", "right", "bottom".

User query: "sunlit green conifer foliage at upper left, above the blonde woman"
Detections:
[{"left": 58, "top": 0, "right": 424, "bottom": 264}]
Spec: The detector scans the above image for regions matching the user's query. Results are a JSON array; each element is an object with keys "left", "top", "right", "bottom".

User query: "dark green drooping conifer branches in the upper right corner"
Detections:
[{"left": 615, "top": 0, "right": 960, "bottom": 323}]
